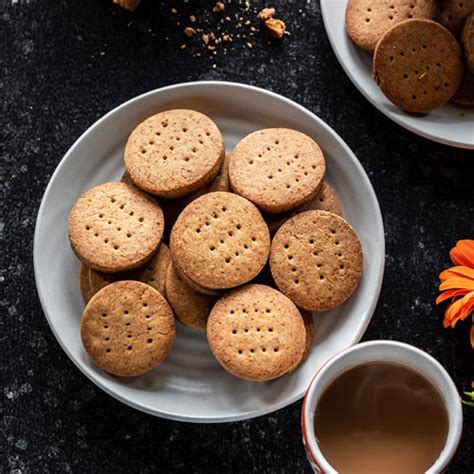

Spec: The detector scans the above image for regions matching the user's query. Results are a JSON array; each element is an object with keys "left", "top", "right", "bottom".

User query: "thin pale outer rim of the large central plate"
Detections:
[{"left": 33, "top": 80, "right": 385, "bottom": 423}]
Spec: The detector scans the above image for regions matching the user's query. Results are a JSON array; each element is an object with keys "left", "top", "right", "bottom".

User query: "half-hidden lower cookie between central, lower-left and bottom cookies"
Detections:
[{"left": 166, "top": 265, "right": 216, "bottom": 329}]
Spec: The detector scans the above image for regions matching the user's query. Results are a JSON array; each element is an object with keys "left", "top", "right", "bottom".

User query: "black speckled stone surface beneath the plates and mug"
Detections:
[{"left": 0, "top": 0, "right": 474, "bottom": 473}]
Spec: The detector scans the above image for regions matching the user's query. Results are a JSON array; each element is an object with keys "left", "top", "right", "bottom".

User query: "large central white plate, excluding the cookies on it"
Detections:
[{"left": 34, "top": 82, "right": 385, "bottom": 423}]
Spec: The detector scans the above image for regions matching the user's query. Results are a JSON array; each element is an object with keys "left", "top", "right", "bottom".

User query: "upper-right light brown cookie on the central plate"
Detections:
[{"left": 229, "top": 128, "right": 326, "bottom": 214}]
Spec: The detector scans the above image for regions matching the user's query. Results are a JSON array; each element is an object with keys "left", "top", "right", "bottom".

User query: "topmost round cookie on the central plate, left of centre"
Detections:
[{"left": 124, "top": 109, "right": 225, "bottom": 198}]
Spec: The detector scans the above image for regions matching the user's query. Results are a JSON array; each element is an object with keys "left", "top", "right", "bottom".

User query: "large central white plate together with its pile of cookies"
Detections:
[{"left": 34, "top": 81, "right": 385, "bottom": 423}]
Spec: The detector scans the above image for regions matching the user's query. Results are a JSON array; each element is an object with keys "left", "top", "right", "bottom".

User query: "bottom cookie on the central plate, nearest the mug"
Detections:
[{"left": 207, "top": 284, "right": 306, "bottom": 382}]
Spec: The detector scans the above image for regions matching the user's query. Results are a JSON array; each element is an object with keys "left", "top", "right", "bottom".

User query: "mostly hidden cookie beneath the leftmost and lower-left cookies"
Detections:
[{"left": 89, "top": 244, "right": 171, "bottom": 296}]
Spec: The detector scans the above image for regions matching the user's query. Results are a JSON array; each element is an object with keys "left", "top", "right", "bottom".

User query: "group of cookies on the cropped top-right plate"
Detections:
[{"left": 346, "top": 0, "right": 474, "bottom": 113}]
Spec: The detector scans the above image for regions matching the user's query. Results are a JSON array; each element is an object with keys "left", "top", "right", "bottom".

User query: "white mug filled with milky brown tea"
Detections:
[{"left": 302, "top": 341, "right": 462, "bottom": 474}]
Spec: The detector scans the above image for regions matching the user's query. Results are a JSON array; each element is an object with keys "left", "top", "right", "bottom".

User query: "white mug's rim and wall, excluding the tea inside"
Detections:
[{"left": 301, "top": 341, "right": 462, "bottom": 474}]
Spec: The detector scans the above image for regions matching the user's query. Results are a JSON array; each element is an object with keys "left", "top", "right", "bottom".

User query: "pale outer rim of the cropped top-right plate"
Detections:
[{"left": 320, "top": 0, "right": 474, "bottom": 150}]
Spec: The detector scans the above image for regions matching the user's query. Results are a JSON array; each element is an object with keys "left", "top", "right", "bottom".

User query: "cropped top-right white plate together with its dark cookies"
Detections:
[{"left": 321, "top": 0, "right": 474, "bottom": 149}]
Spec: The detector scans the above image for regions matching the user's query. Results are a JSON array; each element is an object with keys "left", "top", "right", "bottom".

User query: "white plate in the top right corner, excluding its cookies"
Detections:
[{"left": 321, "top": 0, "right": 474, "bottom": 149}]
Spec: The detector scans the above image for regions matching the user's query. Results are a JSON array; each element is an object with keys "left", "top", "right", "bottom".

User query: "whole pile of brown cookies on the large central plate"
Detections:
[{"left": 68, "top": 110, "right": 363, "bottom": 381}]
